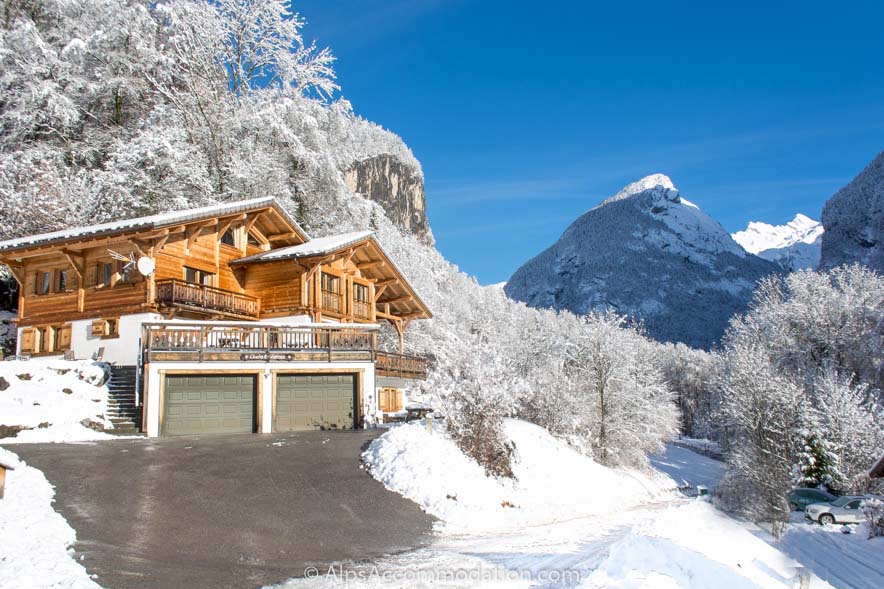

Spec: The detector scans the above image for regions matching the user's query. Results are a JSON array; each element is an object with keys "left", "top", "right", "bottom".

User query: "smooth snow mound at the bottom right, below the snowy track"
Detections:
[{"left": 582, "top": 501, "right": 831, "bottom": 589}]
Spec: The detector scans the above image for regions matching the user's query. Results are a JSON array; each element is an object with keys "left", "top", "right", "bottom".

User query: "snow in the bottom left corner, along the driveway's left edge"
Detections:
[{"left": 0, "top": 448, "right": 99, "bottom": 589}]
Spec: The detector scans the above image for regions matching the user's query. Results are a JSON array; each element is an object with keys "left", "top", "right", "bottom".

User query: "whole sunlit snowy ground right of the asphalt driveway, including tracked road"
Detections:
[{"left": 278, "top": 421, "right": 828, "bottom": 589}]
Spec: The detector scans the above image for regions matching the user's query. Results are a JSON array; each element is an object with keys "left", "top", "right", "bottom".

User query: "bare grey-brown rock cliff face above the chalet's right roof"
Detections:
[{"left": 344, "top": 155, "right": 434, "bottom": 245}]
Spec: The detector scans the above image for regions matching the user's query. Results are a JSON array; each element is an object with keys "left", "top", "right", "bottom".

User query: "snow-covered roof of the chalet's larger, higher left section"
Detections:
[{"left": 0, "top": 196, "right": 310, "bottom": 252}]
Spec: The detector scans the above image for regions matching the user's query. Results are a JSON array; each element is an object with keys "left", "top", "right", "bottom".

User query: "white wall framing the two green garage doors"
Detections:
[{"left": 142, "top": 362, "right": 378, "bottom": 437}]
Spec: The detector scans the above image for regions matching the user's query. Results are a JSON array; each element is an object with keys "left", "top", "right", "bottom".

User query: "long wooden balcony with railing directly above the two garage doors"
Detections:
[{"left": 141, "top": 323, "right": 375, "bottom": 362}]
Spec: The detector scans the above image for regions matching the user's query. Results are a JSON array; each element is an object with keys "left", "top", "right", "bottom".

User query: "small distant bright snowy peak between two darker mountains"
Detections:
[{"left": 731, "top": 213, "right": 823, "bottom": 271}]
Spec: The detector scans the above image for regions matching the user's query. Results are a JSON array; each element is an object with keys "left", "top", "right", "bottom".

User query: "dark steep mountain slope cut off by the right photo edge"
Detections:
[{"left": 820, "top": 152, "right": 884, "bottom": 272}]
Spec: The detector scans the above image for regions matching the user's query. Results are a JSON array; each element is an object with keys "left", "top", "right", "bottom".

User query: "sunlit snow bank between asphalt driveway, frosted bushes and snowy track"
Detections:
[{"left": 363, "top": 420, "right": 675, "bottom": 532}]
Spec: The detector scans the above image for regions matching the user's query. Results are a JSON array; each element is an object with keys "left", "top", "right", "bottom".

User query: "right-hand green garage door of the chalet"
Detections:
[{"left": 274, "top": 374, "right": 356, "bottom": 431}]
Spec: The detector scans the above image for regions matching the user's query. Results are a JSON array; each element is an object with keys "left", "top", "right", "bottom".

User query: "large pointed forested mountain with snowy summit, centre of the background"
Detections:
[{"left": 506, "top": 174, "right": 778, "bottom": 348}]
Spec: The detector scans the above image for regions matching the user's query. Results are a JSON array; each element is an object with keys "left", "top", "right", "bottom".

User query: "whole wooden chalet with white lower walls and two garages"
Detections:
[{"left": 0, "top": 198, "right": 431, "bottom": 435}]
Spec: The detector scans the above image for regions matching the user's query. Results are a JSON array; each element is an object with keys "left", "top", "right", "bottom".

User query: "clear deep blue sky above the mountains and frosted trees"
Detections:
[{"left": 294, "top": 0, "right": 884, "bottom": 284}]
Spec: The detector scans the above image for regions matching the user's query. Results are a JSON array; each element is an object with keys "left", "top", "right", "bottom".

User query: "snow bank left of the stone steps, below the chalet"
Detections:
[{"left": 0, "top": 359, "right": 116, "bottom": 444}]
